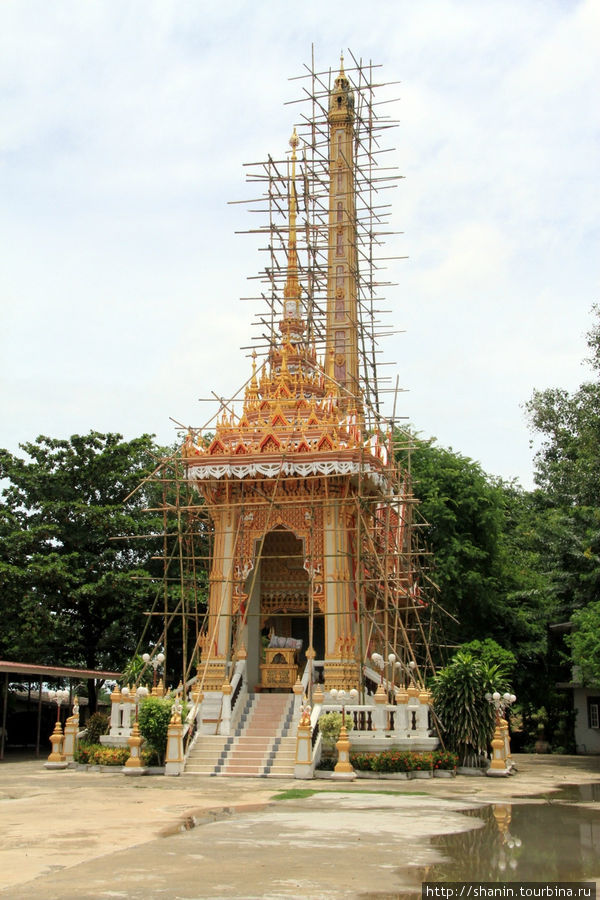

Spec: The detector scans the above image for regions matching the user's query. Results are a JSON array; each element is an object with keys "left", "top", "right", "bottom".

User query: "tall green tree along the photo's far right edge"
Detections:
[{"left": 523, "top": 307, "right": 600, "bottom": 746}]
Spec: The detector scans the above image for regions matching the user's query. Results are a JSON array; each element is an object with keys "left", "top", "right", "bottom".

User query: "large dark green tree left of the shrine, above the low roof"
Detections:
[{"left": 0, "top": 432, "right": 161, "bottom": 709}]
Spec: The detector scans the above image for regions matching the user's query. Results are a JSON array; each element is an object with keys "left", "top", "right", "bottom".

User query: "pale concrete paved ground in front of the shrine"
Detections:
[{"left": 0, "top": 756, "right": 600, "bottom": 900}]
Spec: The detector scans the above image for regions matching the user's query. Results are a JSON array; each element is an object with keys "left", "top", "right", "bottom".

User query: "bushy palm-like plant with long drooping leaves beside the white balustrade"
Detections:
[{"left": 432, "top": 652, "right": 508, "bottom": 766}]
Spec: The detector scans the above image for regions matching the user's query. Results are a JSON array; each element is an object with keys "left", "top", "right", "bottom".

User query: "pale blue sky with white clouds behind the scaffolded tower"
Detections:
[{"left": 0, "top": 0, "right": 600, "bottom": 487}]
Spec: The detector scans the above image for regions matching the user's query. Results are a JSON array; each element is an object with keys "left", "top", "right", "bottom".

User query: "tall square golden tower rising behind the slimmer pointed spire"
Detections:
[{"left": 325, "top": 56, "right": 362, "bottom": 410}]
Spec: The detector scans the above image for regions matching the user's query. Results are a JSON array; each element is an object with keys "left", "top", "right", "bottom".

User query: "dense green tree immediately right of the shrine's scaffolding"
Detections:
[{"left": 405, "top": 439, "right": 546, "bottom": 664}]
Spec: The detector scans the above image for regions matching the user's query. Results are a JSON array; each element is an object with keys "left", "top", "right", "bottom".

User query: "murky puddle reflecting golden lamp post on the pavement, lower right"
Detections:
[{"left": 421, "top": 800, "right": 600, "bottom": 881}]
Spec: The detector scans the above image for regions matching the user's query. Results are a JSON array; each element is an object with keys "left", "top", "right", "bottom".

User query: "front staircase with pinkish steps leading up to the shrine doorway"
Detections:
[{"left": 185, "top": 694, "right": 296, "bottom": 778}]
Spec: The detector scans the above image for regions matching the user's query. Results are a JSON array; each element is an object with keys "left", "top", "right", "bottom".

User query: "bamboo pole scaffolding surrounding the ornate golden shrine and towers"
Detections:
[{"left": 118, "top": 49, "right": 452, "bottom": 696}]
